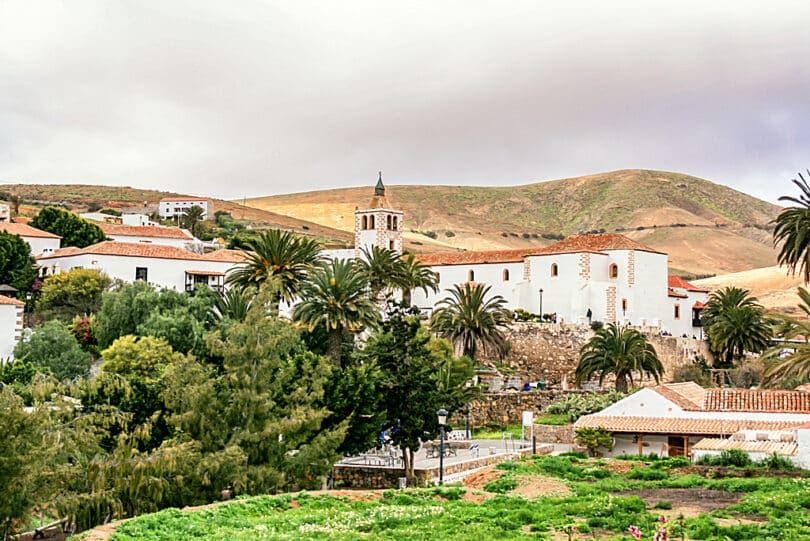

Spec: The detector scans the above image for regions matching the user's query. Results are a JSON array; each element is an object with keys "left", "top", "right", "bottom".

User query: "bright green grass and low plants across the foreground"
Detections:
[{"left": 105, "top": 456, "right": 810, "bottom": 541}]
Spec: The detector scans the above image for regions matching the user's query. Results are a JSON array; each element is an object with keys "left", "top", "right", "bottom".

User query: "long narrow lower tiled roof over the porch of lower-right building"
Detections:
[{"left": 574, "top": 414, "right": 803, "bottom": 435}]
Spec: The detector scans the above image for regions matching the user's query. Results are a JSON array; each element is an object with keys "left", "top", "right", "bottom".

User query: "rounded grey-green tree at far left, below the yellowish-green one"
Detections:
[{"left": 14, "top": 320, "right": 93, "bottom": 380}]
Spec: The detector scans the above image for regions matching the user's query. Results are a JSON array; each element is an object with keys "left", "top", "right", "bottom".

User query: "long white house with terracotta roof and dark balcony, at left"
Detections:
[{"left": 37, "top": 241, "right": 244, "bottom": 292}]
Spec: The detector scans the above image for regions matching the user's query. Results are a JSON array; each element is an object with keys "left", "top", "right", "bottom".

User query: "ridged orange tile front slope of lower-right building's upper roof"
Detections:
[{"left": 704, "top": 389, "right": 810, "bottom": 414}]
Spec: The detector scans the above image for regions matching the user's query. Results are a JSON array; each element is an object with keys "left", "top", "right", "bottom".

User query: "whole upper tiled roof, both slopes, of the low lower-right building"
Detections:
[{"left": 652, "top": 381, "right": 810, "bottom": 414}]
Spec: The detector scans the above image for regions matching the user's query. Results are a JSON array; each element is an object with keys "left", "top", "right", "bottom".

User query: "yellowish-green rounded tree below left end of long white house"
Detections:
[{"left": 36, "top": 269, "right": 112, "bottom": 321}]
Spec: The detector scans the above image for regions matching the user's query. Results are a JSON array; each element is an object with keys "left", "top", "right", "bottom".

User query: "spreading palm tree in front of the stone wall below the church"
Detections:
[{"left": 576, "top": 323, "right": 664, "bottom": 393}]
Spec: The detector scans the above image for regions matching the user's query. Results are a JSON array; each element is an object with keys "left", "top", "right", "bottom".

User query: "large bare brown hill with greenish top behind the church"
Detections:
[{"left": 245, "top": 169, "right": 779, "bottom": 276}]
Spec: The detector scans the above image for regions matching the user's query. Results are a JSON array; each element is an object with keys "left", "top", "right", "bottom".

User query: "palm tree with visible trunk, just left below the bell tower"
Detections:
[{"left": 293, "top": 259, "right": 380, "bottom": 368}]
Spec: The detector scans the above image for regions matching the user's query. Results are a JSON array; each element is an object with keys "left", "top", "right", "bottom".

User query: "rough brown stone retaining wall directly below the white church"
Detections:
[{"left": 482, "top": 323, "right": 709, "bottom": 389}]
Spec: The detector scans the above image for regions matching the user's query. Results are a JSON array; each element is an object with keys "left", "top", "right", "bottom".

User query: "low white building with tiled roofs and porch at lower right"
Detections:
[{"left": 574, "top": 382, "right": 810, "bottom": 456}]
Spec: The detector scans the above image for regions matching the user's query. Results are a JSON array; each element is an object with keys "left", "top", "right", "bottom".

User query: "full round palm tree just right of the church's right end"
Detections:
[{"left": 701, "top": 287, "right": 772, "bottom": 365}]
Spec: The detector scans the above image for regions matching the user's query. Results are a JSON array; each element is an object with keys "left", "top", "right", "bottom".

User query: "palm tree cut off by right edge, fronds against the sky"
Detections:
[{"left": 773, "top": 170, "right": 810, "bottom": 283}]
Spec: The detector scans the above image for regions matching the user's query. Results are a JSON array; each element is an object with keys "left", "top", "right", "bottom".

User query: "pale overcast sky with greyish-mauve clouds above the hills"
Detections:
[{"left": 0, "top": 0, "right": 810, "bottom": 202}]
